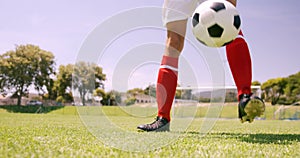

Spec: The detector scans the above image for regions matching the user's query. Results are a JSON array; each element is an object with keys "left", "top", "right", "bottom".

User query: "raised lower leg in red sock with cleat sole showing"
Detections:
[{"left": 226, "top": 32, "right": 265, "bottom": 122}]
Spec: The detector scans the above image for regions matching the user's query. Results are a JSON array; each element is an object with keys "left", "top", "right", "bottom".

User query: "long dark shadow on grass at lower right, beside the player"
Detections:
[{"left": 186, "top": 132, "right": 300, "bottom": 145}]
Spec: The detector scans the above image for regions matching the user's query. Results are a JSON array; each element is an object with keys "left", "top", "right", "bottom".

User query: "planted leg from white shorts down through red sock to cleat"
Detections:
[{"left": 138, "top": 0, "right": 199, "bottom": 131}]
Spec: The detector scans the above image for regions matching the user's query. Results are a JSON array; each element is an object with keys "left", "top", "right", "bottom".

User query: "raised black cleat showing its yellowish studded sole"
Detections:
[{"left": 239, "top": 94, "right": 265, "bottom": 123}]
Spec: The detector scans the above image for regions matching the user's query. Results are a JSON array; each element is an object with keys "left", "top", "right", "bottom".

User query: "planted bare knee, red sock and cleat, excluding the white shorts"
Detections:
[{"left": 138, "top": 20, "right": 187, "bottom": 131}]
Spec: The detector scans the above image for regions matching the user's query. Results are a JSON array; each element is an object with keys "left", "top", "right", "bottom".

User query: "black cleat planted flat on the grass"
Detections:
[{"left": 137, "top": 116, "right": 170, "bottom": 132}]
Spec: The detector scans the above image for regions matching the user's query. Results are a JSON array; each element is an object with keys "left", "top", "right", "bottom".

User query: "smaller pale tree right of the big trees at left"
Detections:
[{"left": 72, "top": 62, "right": 106, "bottom": 105}]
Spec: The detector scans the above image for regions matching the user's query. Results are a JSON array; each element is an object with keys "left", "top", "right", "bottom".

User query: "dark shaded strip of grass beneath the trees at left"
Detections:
[{"left": 0, "top": 105, "right": 64, "bottom": 113}]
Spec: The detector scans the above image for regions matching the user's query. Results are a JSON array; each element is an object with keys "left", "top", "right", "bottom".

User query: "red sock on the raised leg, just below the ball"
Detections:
[{"left": 226, "top": 32, "right": 252, "bottom": 100}]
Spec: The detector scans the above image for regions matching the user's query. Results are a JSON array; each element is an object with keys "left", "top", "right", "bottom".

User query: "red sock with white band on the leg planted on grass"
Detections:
[{"left": 156, "top": 56, "right": 178, "bottom": 121}]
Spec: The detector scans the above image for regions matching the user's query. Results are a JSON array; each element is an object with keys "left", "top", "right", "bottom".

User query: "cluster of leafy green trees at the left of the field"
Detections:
[{"left": 0, "top": 44, "right": 106, "bottom": 105}]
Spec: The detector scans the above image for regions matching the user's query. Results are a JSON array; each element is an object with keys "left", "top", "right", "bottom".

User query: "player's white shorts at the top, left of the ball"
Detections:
[{"left": 162, "top": 0, "right": 205, "bottom": 26}]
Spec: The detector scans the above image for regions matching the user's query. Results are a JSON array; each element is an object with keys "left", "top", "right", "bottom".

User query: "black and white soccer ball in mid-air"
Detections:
[{"left": 192, "top": 0, "right": 241, "bottom": 47}]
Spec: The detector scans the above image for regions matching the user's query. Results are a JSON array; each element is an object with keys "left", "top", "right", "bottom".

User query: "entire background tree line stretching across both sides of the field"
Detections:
[{"left": 0, "top": 44, "right": 300, "bottom": 105}]
